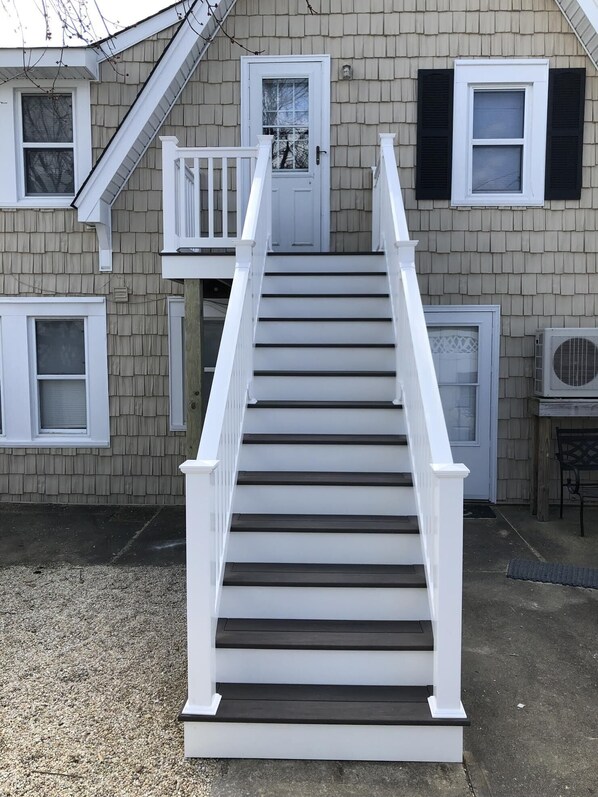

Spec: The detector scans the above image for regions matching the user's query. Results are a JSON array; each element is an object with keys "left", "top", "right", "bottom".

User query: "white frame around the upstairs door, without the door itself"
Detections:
[{"left": 241, "top": 55, "right": 330, "bottom": 252}]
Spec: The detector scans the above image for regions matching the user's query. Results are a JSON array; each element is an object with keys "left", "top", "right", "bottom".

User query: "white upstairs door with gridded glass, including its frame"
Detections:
[{"left": 241, "top": 56, "right": 330, "bottom": 252}]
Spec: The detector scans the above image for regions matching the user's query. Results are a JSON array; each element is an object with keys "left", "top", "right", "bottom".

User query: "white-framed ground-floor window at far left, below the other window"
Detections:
[{"left": 0, "top": 297, "right": 110, "bottom": 448}]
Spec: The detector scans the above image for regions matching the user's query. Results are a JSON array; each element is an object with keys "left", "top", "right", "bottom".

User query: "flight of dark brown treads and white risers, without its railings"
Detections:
[{"left": 181, "top": 255, "right": 467, "bottom": 761}]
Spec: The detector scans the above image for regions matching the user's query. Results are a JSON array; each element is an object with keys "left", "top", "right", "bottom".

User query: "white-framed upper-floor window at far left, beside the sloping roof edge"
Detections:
[{"left": 0, "top": 80, "right": 91, "bottom": 208}]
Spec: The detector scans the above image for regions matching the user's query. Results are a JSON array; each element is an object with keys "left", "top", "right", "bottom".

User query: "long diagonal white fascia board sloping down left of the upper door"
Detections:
[{"left": 73, "top": 0, "right": 236, "bottom": 222}]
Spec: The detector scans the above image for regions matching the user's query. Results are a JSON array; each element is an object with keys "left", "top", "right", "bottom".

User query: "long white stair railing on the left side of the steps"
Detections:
[{"left": 181, "top": 136, "right": 272, "bottom": 714}]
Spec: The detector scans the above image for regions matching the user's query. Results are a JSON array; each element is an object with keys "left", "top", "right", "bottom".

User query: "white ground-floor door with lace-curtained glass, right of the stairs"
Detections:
[{"left": 426, "top": 306, "right": 500, "bottom": 501}]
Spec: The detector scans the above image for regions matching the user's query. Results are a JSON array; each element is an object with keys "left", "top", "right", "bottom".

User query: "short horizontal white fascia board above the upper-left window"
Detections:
[{"left": 0, "top": 47, "right": 100, "bottom": 80}]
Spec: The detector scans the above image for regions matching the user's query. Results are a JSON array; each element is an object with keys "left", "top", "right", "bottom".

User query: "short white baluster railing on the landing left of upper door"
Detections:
[{"left": 161, "top": 136, "right": 257, "bottom": 252}]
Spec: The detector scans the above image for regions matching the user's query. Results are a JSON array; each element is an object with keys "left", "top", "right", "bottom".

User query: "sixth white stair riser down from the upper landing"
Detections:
[{"left": 252, "top": 375, "right": 396, "bottom": 401}]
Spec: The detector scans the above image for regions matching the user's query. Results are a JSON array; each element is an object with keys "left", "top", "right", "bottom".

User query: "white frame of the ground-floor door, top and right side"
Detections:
[{"left": 424, "top": 304, "right": 500, "bottom": 503}]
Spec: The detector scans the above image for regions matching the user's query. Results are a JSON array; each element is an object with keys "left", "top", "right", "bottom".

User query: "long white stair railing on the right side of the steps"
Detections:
[{"left": 372, "top": 133, "right": 469, "bottom": 718}]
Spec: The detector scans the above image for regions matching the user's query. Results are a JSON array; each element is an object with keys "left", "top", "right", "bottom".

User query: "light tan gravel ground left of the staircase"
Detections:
[{"left": 0, "top": 566, "right": 218, "bottom": 797}]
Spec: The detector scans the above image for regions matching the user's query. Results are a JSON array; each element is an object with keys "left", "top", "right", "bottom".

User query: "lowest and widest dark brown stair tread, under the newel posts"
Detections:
[{"left": 179, "top": 683, "right": 469, "bottom": 726}]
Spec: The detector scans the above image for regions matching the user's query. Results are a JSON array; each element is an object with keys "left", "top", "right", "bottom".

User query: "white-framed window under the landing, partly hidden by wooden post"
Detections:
[{"left": 168, "top": 296, "right": 227, "bottom": 431}]
